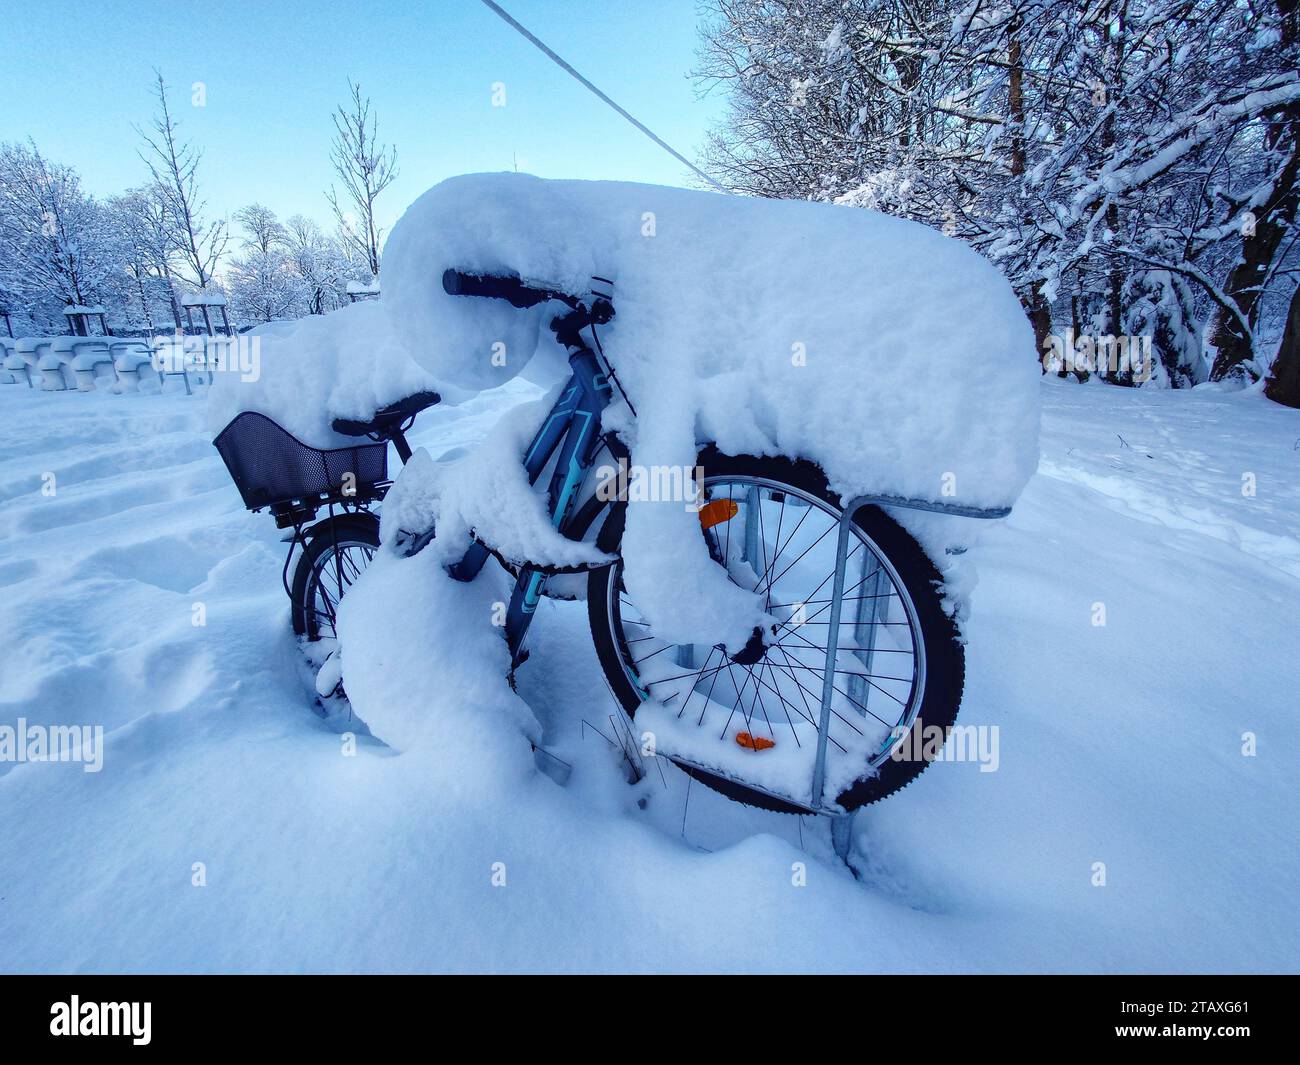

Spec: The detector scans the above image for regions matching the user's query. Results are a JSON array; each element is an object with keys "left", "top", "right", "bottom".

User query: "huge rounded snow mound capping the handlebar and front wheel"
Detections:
[{"left": 382, "top": 174, "right": 1039, "bottom": 506}]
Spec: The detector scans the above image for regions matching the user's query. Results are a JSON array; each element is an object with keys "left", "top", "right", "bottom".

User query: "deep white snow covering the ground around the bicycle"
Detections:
[{"left": 0, "top": 380, "right": 1300, "bottom": 971}]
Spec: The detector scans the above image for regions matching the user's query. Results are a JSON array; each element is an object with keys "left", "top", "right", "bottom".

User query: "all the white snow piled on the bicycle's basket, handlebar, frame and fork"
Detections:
[{"left": 200, "top": 174, "right": 1039, "bottom": 646}]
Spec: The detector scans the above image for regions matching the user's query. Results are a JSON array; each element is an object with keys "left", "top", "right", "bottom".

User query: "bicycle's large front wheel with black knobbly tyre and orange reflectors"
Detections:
[{"left": 588, "top": 450, "right": 965, "bottom": 813}]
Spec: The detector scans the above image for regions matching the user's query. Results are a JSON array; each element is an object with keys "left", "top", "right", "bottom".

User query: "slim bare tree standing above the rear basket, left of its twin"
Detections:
[{"left": 137, "top": 70, "right": 229, "bottom": 289}]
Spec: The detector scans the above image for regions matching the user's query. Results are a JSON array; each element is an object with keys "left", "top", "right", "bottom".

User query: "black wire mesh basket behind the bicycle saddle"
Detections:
[{"left": 212, "top": 411, "right": 389, "bottom": 510}]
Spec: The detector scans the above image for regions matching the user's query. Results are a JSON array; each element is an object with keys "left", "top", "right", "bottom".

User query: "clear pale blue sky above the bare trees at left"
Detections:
[{"left": 0, "top": 0, "right": 722, "bottom": 232}]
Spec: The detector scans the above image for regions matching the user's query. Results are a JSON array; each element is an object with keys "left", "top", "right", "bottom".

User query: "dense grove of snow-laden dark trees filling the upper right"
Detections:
[{"left": 699, "top": 0, "right": 1300, "bottom": 392}]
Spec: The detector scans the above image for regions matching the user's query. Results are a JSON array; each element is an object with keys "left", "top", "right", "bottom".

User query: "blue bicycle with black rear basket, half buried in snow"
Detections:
[{"left": 216, "top": 270, "right": 965, "bottom": 814}]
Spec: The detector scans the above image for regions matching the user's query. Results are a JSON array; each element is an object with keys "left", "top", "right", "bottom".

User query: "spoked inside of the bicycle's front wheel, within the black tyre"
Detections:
[{"left": 606, "top": 475, "right": 924, "bottom": 802}]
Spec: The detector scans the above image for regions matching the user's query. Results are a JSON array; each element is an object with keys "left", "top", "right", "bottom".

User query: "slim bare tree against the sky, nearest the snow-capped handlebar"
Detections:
[{"left": 326, "top": 81, "right": 398, "bottom": 277}]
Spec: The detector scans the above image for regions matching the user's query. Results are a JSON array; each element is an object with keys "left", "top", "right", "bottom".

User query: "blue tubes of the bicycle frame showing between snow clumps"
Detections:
[{"left": 449, "top": 345, "right": 612, "bottom": 668}]
